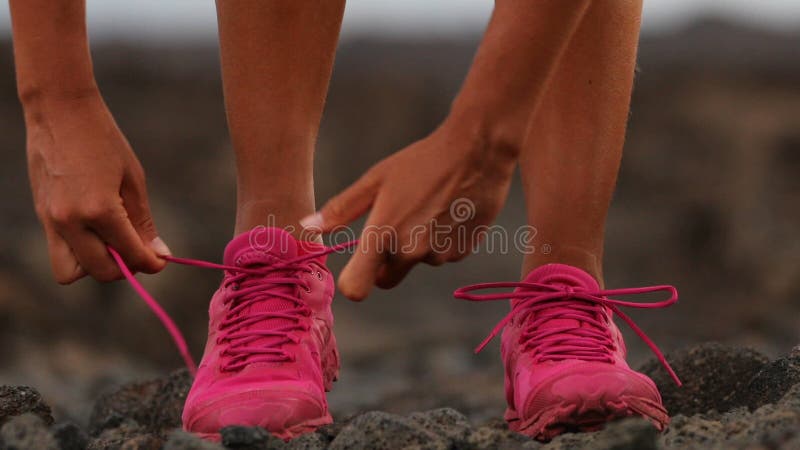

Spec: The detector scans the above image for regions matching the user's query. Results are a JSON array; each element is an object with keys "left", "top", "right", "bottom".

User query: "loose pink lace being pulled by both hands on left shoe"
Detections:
[{"left": 108, "top": 241, "right": 358, "bottom": 375}]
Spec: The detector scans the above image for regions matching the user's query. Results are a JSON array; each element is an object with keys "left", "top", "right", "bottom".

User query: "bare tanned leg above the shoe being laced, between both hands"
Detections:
[{"left": 217, "top": 0, "right": 344, "bottom": 233}]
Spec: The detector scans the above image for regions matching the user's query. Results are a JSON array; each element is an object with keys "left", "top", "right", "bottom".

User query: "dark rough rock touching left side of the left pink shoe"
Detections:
[{"left": 89, "top": 369, "right": 192, "bottom": 436}]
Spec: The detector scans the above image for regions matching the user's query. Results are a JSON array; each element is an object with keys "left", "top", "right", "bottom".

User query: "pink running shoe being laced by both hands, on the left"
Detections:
[{"left": 177, "top": 228, "right": 339, "bottom": 439}]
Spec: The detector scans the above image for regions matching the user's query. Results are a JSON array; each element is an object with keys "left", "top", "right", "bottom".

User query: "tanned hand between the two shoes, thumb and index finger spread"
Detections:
[{"left": 301, "top": 122, "right": 516, "bottom": 301}]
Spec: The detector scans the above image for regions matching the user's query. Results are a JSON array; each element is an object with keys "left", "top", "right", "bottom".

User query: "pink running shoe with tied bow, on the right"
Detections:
[{"left": 454, "top": 264, "right": 680, "bottom": 440}]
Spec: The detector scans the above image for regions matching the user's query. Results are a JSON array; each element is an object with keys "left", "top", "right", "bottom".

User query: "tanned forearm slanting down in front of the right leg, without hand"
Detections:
[{"left": 449, "top": 0, "right": 589, "bottom": 156}]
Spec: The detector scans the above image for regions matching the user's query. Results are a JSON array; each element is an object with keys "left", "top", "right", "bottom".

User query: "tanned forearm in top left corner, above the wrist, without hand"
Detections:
[{"left": 9, "top": 0, "right": 97, "bottom": 114}]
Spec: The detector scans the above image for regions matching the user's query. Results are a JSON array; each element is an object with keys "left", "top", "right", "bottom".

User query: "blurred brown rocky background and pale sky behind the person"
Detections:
[{"left": 0, "top": 0, "right": 800, "bottom": 422}]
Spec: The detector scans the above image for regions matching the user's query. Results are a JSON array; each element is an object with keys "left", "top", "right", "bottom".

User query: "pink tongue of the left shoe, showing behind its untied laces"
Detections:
[{"left": 224, "top": 228, "right": 298, "bottom": 356}]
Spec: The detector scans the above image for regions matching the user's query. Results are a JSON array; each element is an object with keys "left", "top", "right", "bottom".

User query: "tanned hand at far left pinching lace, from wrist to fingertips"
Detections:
[{"left": 25, "top": 92, "right": 169, "bottom": 284}]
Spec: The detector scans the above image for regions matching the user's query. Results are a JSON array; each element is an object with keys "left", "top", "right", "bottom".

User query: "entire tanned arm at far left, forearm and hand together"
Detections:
[{"left": 9, "top": 0, "right": 169, "bottom": 284}]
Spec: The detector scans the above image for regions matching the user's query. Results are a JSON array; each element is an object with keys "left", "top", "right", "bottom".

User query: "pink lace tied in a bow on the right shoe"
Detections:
[{"left": 453, "top": 282, "right": 681, "bottom": 386}]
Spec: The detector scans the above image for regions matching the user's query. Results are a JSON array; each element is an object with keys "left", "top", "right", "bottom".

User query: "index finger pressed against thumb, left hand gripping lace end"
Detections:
[{"left": 91, "top": 212, "right": 167, "bottom": 273}]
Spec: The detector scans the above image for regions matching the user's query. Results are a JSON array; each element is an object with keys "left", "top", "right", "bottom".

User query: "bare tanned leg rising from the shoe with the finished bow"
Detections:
[{"left": 520, "top": 0, "right": 642, "bottom": 285}]
